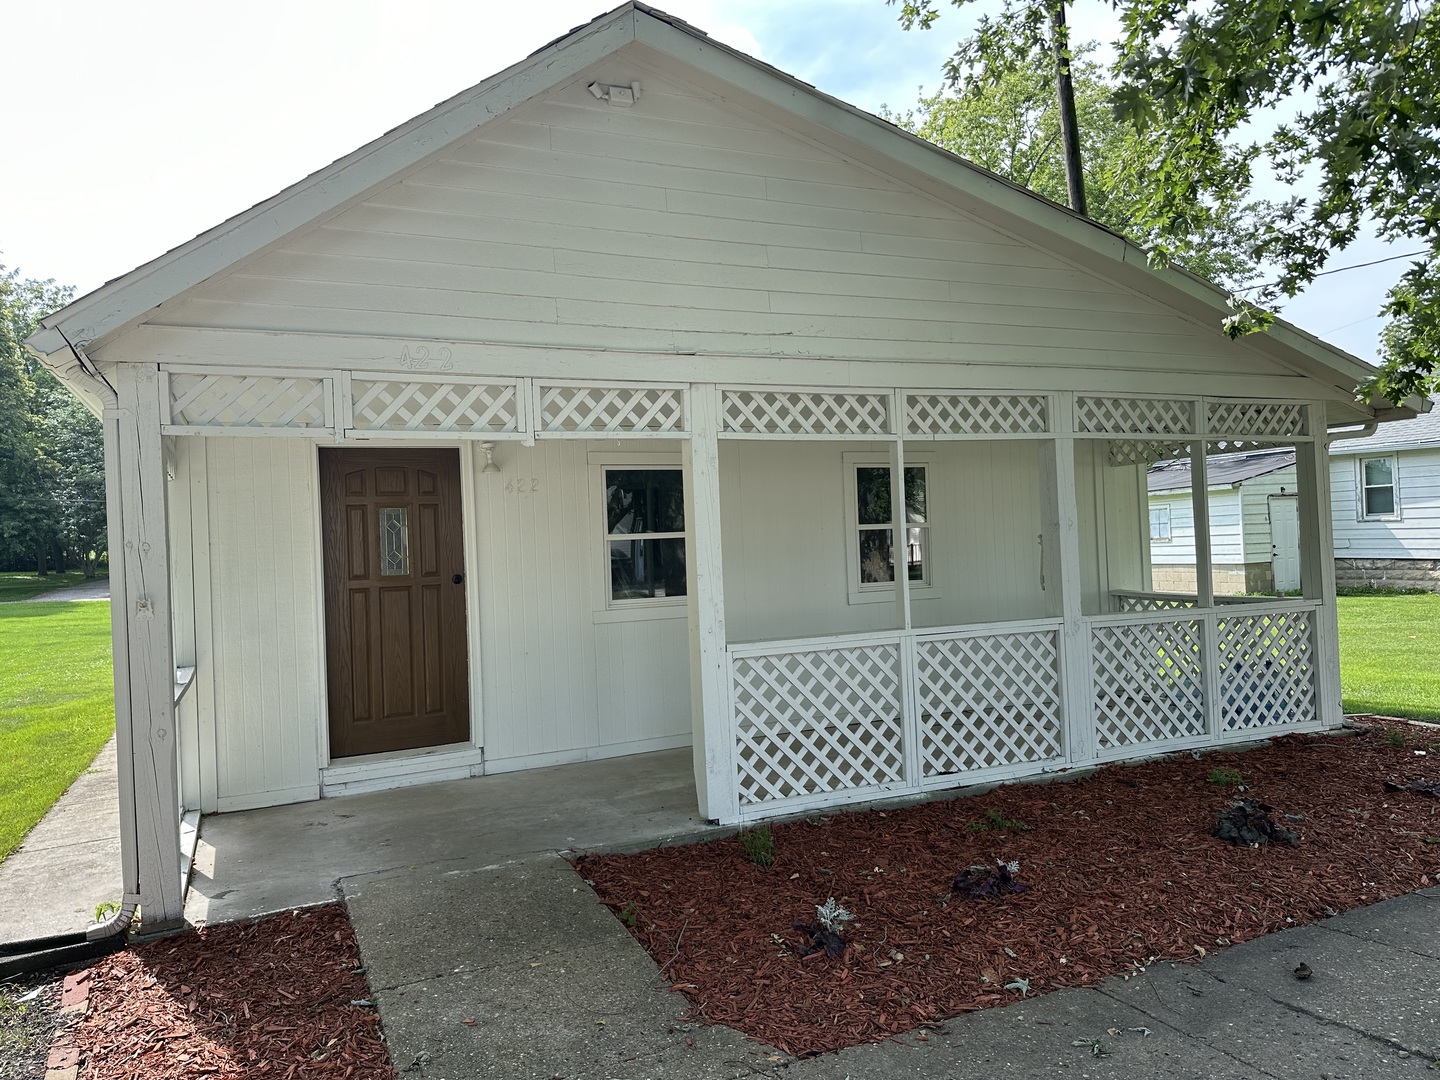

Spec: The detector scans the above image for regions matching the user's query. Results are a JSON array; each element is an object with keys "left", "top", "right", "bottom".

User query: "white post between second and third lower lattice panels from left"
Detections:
[{"left": 1050, "top": 393, "right": 1094, "bottom": 765}]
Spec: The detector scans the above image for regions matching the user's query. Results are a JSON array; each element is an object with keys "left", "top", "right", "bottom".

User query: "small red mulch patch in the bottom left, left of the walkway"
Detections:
[{"left": 72, "top": 904, "right": 396, "bottom": 1080}]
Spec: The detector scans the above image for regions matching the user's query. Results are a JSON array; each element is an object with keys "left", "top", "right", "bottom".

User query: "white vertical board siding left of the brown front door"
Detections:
[{"left": 200, "top": 439, "right": 325, "bottom": 809}]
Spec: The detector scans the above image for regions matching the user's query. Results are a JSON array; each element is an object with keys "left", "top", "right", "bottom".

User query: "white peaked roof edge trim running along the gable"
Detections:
[{"left": 27, "top": 0, "right": 1418, "bottom": 422}]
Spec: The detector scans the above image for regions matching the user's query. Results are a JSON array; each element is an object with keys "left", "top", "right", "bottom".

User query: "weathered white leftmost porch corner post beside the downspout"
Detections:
[{"left": 107, "top": 364, "right": 184, "bottom": 932}]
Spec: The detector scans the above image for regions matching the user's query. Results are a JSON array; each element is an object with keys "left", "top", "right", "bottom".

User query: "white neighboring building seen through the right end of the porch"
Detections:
[{"left": 1146, "top": 448, "right": 1300, "bottom": 596}]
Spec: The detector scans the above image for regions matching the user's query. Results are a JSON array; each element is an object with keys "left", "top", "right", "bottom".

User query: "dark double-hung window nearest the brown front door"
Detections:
[{"left": 605, "top": 467, "right": 685, "bottom": 606}]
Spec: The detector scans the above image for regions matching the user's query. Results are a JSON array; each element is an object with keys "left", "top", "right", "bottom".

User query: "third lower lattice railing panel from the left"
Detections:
[{"left": 1090, "top": 621, "right": 1205, "bottom": 750}]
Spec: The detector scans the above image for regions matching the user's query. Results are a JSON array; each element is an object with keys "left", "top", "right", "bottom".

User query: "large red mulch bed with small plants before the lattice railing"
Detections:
[{"left": 577, "top": 724, "right": 1440, "bottom": 1054}]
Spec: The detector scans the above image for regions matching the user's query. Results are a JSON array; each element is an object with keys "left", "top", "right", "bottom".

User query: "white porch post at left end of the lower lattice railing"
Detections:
[{"left": 684, "top": 383, "right": 740, "bottom": 822}]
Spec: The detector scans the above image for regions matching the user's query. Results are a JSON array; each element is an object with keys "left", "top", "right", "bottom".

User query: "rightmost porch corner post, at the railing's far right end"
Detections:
[{"left": 1295, "top": 403, "right": 1345, "bottom": 727}]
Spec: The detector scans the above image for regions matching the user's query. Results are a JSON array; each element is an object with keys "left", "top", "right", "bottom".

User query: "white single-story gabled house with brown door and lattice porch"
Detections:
[{"left": 29, "top": 3, "right": 1417, "bottom": 927}]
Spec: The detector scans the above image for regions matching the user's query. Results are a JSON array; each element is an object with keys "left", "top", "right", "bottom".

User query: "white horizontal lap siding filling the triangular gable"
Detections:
[{"left": 153, "top": 62, "right": 1279, "bottom": 373}]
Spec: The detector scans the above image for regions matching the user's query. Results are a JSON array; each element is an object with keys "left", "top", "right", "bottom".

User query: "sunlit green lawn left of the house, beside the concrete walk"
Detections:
[{"left": 0, "top": 600, "right": 115, "bottom": 858}]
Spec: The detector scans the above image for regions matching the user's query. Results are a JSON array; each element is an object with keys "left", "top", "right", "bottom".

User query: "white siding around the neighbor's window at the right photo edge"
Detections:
[{"left": 1331, "top": 446, "right": 1440, "bottom": 559}]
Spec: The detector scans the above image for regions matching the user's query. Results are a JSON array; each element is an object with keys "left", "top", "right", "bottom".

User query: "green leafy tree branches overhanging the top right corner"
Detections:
[{"left": 891, "top": 0, "right": 1440, "bottom": 400}]
